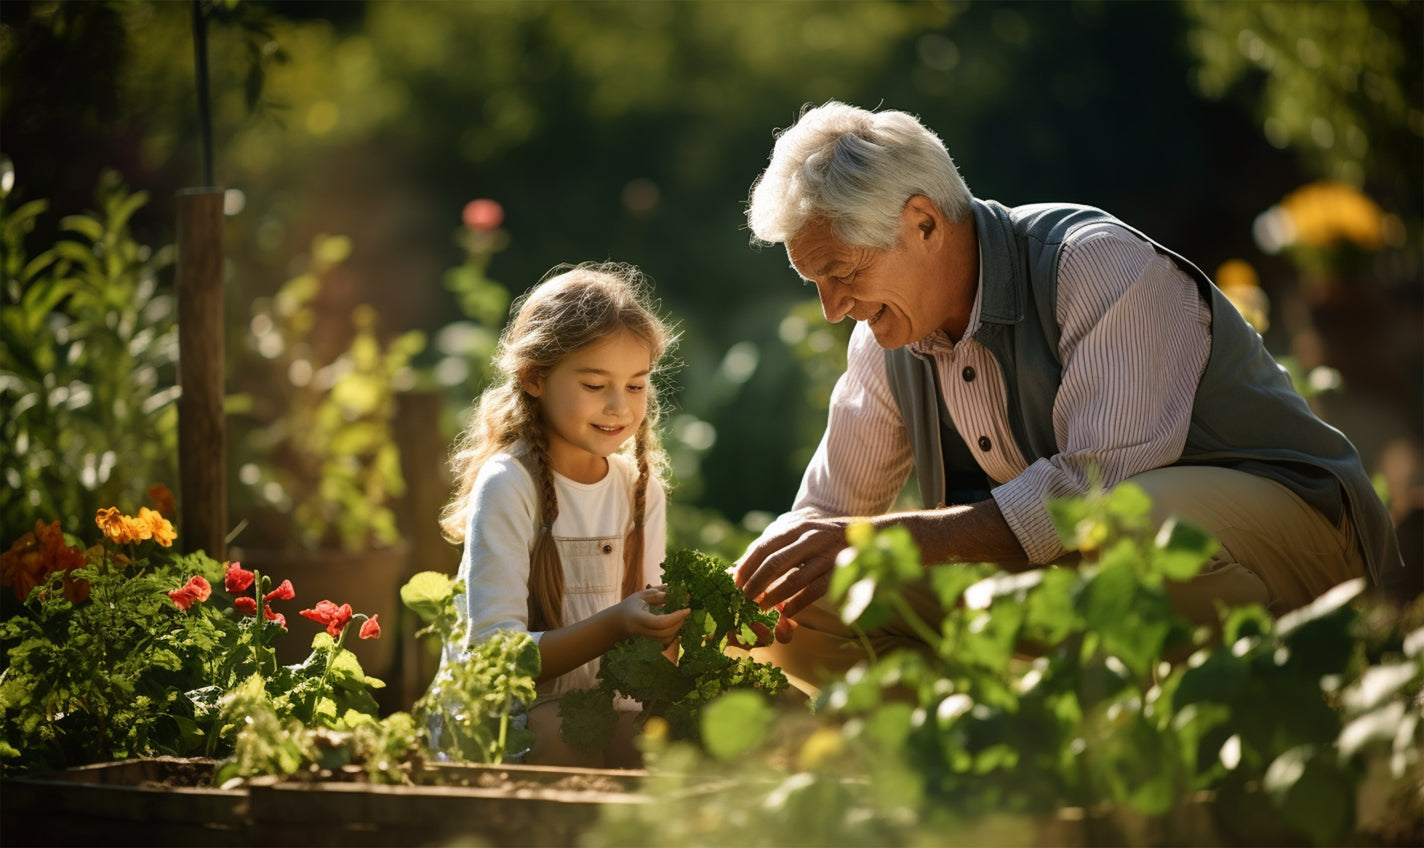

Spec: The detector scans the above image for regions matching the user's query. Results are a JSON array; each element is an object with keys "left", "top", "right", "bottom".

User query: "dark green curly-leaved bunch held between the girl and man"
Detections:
[{"left": 560, "top": 549, "right": 787, "bottom": 750}]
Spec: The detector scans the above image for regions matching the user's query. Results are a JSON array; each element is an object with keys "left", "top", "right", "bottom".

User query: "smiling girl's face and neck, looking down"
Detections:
[{"left": 524, "top": 330, "right": 652, "bottom": 482}]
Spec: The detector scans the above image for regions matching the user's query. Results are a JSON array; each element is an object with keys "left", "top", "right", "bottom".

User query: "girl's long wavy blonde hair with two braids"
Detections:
[{"left": 440, "top": 262, "right": 674, "bottom": 630}]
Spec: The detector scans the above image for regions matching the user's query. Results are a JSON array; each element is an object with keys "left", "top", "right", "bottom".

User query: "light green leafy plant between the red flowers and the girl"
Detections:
[{"left": 400, "top": 572, "right": 540, "bottom": 763}]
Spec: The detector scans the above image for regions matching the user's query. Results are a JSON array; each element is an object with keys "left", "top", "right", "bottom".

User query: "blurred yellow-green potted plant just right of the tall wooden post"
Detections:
[{"left": 228, "top": 236, "right": 424, "bottom": 551}]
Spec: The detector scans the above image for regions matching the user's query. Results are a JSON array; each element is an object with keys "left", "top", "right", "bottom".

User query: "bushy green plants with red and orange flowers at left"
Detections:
[{"left": 0, "top": 489, "right": 383, "bottom": 771}]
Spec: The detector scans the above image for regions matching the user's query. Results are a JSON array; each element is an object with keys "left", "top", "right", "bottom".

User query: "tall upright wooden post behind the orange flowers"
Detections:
[{"left": 177, "top": 188, "right": 228, "bottom": 559}]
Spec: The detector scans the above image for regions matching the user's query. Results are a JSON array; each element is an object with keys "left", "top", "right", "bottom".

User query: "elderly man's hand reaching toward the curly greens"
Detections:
[{"left": 733, "top": 518, "right": 852, "bottom": 642}]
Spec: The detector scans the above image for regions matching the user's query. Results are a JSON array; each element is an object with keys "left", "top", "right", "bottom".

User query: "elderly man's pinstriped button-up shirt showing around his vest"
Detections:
[{"left": 768, "top": 223, "right": 1212, "bottom": 563}]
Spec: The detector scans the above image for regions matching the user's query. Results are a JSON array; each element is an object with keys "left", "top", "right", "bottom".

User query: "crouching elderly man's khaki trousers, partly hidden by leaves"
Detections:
[{"left": 753, "top": 465, "right": 1366, "bottom": 693}]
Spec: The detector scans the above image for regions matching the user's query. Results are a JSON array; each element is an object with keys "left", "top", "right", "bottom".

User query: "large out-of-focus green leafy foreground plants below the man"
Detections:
[{"left": 588, "top": 485, "right": 1424, "bottom": 845}]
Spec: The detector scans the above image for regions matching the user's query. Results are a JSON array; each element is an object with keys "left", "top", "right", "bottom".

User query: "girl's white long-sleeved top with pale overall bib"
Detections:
[{"left": 444, "top": 454, "right": 666, "bottom": 700}]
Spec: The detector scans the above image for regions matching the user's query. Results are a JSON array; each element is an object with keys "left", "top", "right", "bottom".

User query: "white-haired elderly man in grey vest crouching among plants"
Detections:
[{"left": 736, "top": 102, "right": 1404, "bottom": 687}]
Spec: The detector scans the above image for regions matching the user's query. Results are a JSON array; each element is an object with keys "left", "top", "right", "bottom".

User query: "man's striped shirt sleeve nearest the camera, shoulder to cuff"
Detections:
[{"left": 993, "top": 225, "right": 1210, "bottom": 562}]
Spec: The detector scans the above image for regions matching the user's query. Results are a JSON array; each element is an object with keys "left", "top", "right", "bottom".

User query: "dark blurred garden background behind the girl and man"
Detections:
[{"left": 0, "top": 0, "right": 1424, "bottom": 569}]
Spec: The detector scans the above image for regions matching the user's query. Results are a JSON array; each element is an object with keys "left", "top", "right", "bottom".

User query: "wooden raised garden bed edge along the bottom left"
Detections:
[{"left": 0, "top": 757, "right": 646, "bottom": 848}]
